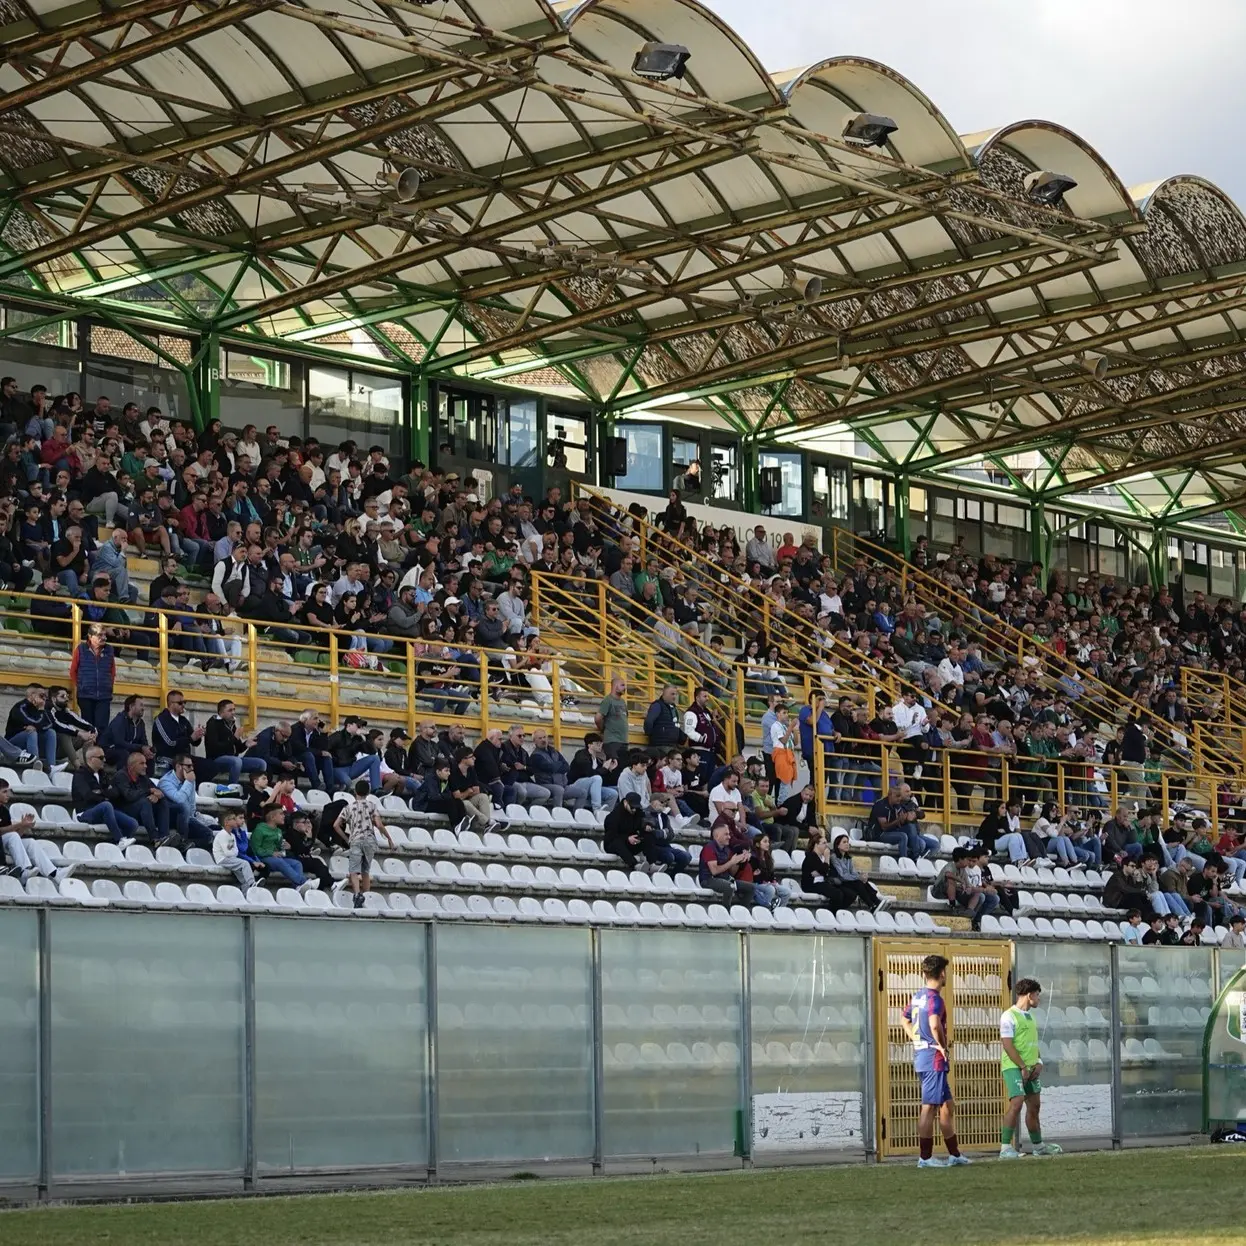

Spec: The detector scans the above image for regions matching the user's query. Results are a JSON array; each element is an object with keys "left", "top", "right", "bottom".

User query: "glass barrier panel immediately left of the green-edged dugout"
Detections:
[{"left": 1116, "top": 947, "right": 1212, "bottom": 1139}]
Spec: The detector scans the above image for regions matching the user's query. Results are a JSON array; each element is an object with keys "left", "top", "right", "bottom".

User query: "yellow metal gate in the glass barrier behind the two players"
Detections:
[{"left": 873, "top": 939, "right": 1012, "bottom": 1156}]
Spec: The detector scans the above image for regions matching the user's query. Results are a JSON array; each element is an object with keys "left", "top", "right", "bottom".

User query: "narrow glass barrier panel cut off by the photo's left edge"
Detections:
[{"left": 0, "top": 912, "right": 39, "bottom": 1181}]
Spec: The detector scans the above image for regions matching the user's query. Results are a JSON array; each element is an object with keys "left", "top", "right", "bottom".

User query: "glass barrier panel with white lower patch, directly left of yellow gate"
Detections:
[{"left": 749, "top": 935, "right": 872, "bottom": 1155}]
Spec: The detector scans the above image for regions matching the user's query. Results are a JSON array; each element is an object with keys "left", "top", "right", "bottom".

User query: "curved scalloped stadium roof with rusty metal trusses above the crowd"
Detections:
[{"left": 0, "top": 0, "right": 1246, "bottom": 520}]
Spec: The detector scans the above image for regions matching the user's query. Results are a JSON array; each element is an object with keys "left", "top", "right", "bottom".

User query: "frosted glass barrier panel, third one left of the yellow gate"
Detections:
[{"left": 437, "top": 926, "right": 593, "bottom": 1163}]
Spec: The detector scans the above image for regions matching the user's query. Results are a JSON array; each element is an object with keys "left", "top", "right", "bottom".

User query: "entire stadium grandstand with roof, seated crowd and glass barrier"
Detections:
[{"left": 0, "top": 0, "right": 1246, "bottom": 1196}]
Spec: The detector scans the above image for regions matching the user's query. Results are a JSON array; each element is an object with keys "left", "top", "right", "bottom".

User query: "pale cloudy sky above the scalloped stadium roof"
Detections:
[{"left": 705, "top": 0, "right": 1246, "bottom": 209}]
